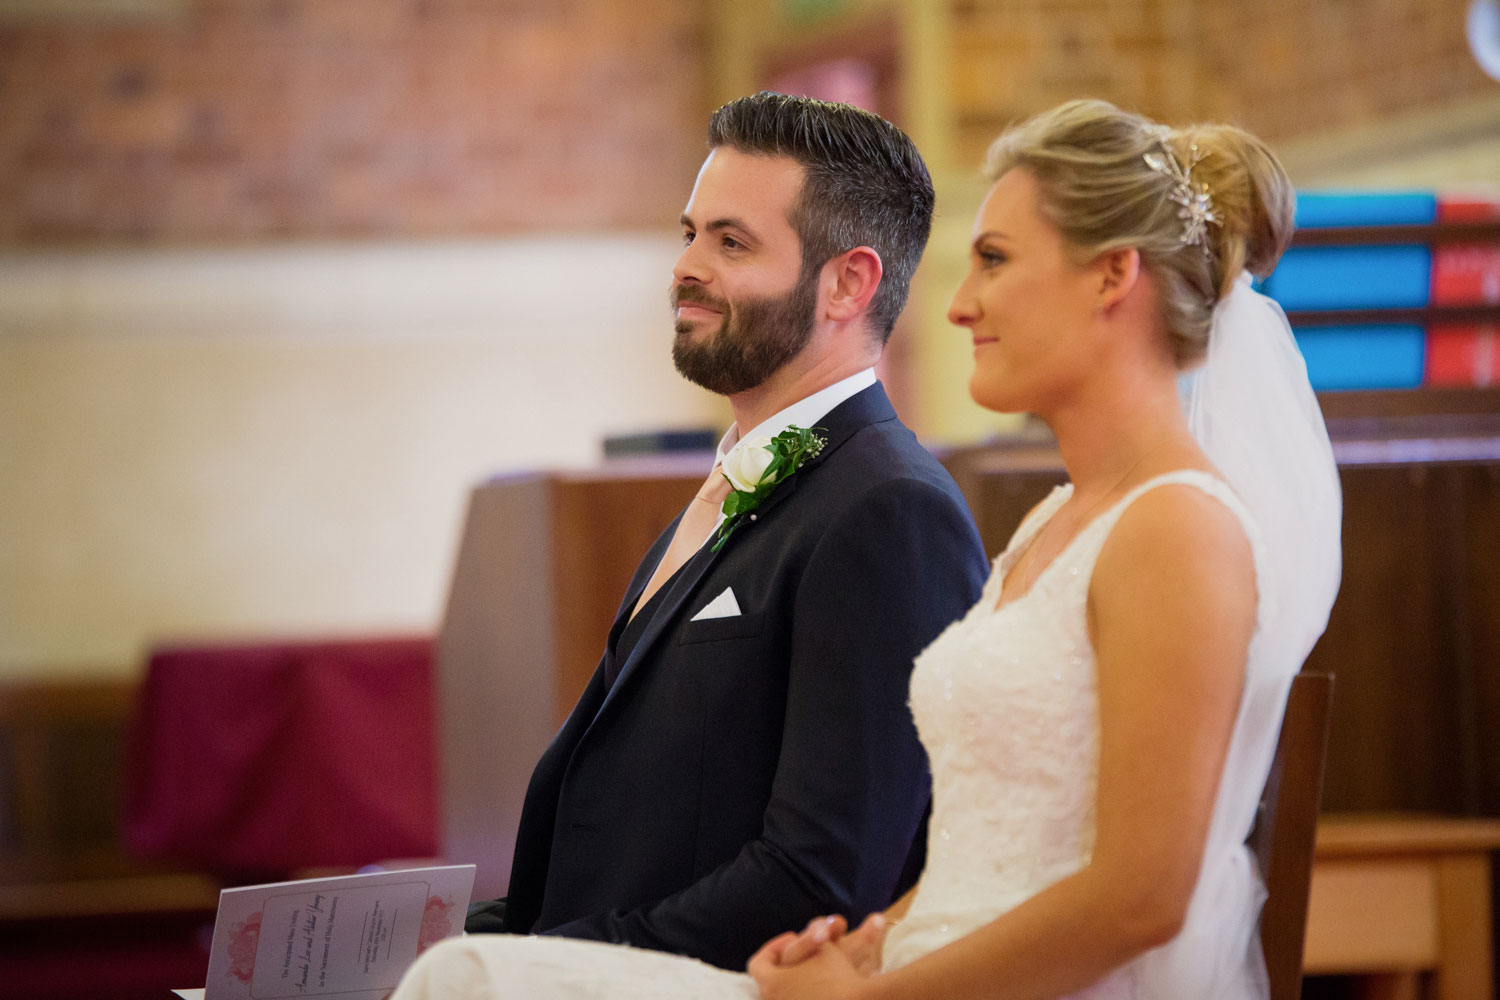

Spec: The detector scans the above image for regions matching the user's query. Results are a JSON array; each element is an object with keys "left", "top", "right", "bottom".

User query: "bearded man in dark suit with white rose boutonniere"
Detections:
[{"left": 468, "top": 93, "right": 986, "bottom": 969}]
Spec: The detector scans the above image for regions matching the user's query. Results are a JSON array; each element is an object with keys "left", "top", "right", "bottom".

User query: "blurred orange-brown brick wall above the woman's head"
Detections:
[{"left": 951, "top": 0, "right": 1496, "bottom": 165}]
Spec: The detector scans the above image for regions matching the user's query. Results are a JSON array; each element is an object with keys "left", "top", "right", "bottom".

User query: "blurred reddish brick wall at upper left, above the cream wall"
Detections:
[{"left": 0, "top": 0, "right": 705, "bottom": 246}]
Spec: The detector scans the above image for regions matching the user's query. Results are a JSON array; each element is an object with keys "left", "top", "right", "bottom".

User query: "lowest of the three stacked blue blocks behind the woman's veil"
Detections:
[{"left": 1293, "top": 324, "right": 1427, "bottom": 391}]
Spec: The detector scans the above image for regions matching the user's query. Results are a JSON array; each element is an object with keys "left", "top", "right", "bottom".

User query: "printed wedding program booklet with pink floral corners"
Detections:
[{"left": 174, "top": 865, "right": 474, "bottom": 1000}]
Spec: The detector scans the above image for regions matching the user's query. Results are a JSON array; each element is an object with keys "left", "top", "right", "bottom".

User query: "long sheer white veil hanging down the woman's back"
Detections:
[{"left": 1139, "top": 274, "right": 1343, "bottom": 1000}]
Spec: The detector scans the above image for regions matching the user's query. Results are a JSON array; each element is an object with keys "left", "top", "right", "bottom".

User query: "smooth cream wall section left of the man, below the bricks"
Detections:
[{"left": 0, "top": 234, "right": 728, "bottom": 679}]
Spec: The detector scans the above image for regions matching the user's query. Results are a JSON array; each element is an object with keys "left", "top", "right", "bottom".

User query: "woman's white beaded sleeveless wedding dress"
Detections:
[{"left": 396, "top": 471, "right": 1301, "bottom": 1000}]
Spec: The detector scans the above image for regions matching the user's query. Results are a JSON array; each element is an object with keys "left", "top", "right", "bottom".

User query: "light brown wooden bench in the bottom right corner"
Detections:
[{"left": 1304, "top": 814, "right": 1500, "bottom": 1000}]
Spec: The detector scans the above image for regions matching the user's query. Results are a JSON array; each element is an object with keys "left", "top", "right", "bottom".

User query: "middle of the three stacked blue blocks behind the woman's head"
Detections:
[{"left": 1263, "top": 243, "right": 1433, "bottom": 312}]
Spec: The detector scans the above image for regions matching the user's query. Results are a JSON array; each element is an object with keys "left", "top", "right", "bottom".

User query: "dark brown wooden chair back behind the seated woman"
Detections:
[{"left": 1248, "top": 673, "right": 1334, "bottom": 1000}]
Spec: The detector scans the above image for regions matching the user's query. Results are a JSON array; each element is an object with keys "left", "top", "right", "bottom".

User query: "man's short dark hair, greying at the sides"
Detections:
[{"left": 708, "top": 90, "right": 933, "bottom": 342}]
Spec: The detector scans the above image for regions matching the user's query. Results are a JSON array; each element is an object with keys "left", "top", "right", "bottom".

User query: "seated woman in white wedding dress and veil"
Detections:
[{"left": 396, "top": 100, "right": 1341, "bottom": 1000}]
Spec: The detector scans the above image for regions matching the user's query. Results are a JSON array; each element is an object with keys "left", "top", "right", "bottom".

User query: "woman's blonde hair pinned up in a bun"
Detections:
[{"left": 984, "top": 100, "right": 1296, "bottom": 367}]
